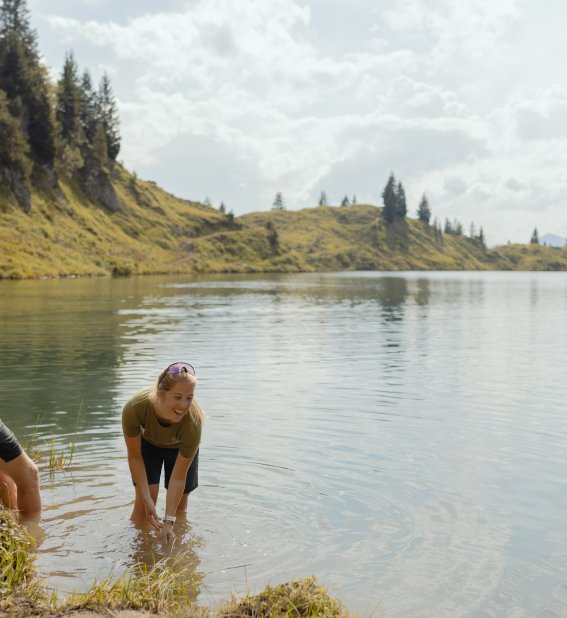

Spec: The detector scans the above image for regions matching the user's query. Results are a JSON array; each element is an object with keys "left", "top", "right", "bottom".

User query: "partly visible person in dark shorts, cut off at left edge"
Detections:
[{"left": 0, "top": 420, "right": 41, "bottom": 519}]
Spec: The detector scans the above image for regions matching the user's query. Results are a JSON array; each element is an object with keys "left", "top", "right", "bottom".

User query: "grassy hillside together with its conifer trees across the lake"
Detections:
[{"left": 0, "top": 0, "right": 567, "bottom": 278}]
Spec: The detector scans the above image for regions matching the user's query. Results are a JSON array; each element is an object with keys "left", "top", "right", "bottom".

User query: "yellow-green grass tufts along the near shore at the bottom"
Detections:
[{"left": 0, "top": 508, "right": 360, "bottom": 618}]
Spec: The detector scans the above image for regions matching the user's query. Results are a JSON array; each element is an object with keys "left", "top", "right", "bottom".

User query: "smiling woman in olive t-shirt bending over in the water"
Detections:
[{"left": 122, "top": 363, "right": 205, "bottom": 543}]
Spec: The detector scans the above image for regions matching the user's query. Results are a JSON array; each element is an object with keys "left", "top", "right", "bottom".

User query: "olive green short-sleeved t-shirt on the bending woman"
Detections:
[{"left": 122, "top": 388, "right": 201, "bottom": 459}]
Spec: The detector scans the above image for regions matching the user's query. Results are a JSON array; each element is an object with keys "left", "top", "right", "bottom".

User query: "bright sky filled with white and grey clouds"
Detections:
[{"left": 28, "top": 0, "right": 567, "bottom": 244}]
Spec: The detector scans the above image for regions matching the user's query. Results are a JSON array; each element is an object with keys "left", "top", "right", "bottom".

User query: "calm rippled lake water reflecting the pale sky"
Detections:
[{"left": 0, "top": 273, "right": 567, "bottom": 617}]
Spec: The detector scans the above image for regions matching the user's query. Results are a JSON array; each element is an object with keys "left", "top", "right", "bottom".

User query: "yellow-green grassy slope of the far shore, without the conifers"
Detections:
[{"left": 0, "top": 164, "right": 567, "bottom": 278}]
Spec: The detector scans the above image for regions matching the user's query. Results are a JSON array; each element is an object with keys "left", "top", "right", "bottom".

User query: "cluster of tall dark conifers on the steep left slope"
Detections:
[{"left": 0, "top": 0, "right": 120, "bottom": 207}]
